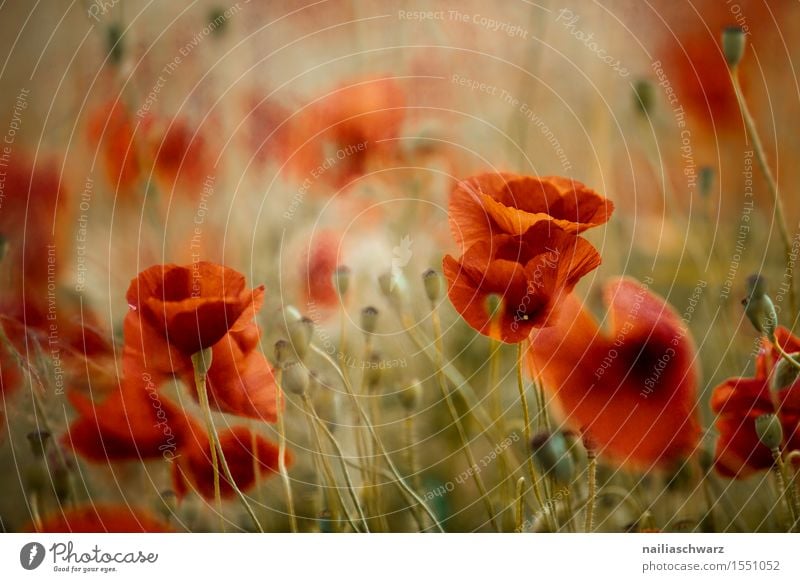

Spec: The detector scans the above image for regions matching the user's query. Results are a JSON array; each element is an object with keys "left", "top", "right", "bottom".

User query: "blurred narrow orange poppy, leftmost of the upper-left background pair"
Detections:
[{"left": 88, "top": 100, "right": 141, "bottom": 194}]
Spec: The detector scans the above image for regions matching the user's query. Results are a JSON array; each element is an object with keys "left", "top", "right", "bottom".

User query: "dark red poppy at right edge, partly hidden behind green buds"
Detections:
[{"left": 711, "top": 327, "right": 800, "bottom": 478}]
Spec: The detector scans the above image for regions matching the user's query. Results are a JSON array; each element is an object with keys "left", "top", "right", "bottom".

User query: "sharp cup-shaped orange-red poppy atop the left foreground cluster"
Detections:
[{"left": 125, "top": 262, "right": 264, "bottom": 364}]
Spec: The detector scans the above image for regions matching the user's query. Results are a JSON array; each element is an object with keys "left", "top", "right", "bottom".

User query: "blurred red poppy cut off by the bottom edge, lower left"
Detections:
[{"left": 33, "top": 504, "right": 174, "bottom": 533}]
